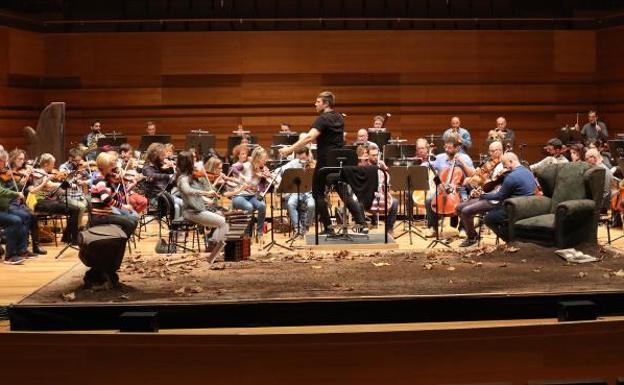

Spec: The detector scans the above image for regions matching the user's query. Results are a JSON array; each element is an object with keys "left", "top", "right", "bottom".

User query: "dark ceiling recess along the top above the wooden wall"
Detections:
[{"left": 0, "top": 0, "right": 624, "bottom": 32}]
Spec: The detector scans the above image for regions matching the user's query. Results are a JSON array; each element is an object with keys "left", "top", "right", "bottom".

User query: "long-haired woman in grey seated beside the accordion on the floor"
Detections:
[{"left": 177, "top": 151, "right": 228, "bottom": 261}]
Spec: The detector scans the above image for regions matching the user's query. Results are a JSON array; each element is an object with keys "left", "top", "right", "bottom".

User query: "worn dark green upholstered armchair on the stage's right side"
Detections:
[{"left": 504, "top": 162, "right": 605, "bottom": 248}]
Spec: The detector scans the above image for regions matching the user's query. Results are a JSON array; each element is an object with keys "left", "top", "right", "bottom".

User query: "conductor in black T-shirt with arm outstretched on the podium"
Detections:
[{"left": 279, "top": 91, "right": 366, "bottom": 235}]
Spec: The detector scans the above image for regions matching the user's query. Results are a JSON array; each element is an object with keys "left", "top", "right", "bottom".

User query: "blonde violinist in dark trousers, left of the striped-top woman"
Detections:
[{"left": 27, "top": 153, "right": 80, "bottom": 245}]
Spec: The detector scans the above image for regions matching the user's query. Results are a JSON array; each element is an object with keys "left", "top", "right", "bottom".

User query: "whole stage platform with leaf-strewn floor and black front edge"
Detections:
[{"left": 9, "top": 222, "right": 624, "bottom": 330}]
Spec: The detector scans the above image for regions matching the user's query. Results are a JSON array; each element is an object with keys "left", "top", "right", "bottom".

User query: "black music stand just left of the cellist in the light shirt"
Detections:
[{"left": 390, "top": 166, "right": 429, "bottom": 245}]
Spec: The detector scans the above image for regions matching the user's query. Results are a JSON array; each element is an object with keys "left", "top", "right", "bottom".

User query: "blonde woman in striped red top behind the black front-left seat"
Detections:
[{"left": 91, "top": 152, "right": 139, "bottom": 238}]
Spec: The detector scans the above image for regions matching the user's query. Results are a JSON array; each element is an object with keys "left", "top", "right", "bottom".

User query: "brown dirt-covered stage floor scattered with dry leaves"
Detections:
[{"left": 21, "top": 243, "right": 624, "bottom": 304}]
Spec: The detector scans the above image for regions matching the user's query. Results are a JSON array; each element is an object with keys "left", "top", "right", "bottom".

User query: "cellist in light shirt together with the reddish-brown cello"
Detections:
[{"left": 425, "top": 135, "right": 475, "bottom": 238}]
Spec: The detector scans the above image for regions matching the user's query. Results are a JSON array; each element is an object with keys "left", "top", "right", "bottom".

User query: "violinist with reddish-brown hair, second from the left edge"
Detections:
[{"left": 5, "top": 149, "right": 47, "bottom": 254}]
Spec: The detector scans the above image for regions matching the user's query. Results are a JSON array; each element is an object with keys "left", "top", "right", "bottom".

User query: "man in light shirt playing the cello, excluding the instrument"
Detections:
[{"left": 425, "top": 136, "right": 475, "bottom": 237}]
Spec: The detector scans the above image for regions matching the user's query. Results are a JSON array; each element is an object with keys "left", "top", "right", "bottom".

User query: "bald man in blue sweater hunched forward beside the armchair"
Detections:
[{"left": 480, "top": 152, "right": 537, "bottom": 242}]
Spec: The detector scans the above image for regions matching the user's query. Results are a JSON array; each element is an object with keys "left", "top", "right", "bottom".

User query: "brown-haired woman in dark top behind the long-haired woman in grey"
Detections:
[{"left": 142, "top": 143, "right": 183, "bottom": 219}]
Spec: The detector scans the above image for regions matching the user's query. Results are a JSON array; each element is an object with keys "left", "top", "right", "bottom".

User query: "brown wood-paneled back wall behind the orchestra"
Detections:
[{"left": 0, "top": 28, "right": 624, "bottom": 159}]
